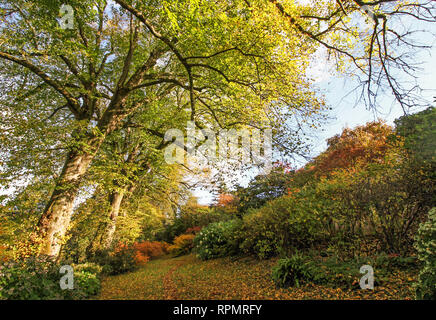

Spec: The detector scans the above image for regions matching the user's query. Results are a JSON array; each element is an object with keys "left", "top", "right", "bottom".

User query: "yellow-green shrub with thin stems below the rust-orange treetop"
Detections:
[{"left": 328, "top": 159, "right": 434, "bottom": 254}]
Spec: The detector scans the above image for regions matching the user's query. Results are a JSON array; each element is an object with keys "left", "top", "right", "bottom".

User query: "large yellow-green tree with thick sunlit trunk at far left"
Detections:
[{"left": 0, "top": 0, "right": 322, "bottom": 255}]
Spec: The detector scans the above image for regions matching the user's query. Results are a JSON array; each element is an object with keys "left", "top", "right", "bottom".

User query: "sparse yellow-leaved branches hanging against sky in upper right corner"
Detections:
[{"left": 268, "top": 0, "right": 436, "bottom": 113}]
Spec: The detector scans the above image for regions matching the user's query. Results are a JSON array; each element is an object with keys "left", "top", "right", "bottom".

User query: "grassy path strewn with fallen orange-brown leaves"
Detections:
[{"left": 98, "top": 255, "right": 414, "bottom": 300}]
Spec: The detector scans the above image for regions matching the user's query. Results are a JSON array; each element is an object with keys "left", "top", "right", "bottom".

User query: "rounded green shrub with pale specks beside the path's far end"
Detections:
[{"left": 194, "top": 219, "right": 242, "bottom": 260}]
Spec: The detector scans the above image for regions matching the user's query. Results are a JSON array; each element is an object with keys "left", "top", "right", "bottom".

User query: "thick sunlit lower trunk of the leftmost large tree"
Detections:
[{"left": 37, "top": 151, "right": 99, "bottom": 256}]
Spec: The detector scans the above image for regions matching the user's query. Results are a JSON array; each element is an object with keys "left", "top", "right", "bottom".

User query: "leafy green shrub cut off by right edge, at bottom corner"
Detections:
[{"left": 415, "top": 208, "right": 436, "bottom": 300}]
